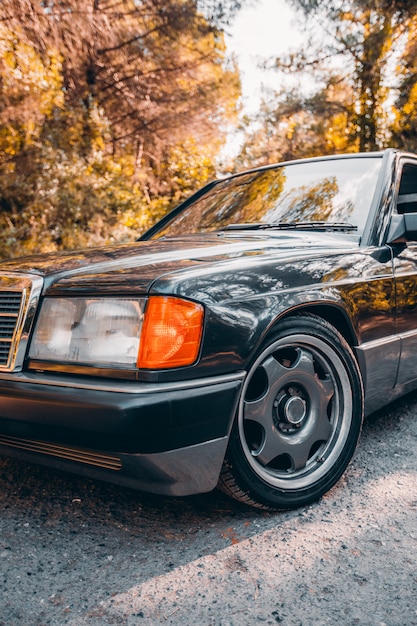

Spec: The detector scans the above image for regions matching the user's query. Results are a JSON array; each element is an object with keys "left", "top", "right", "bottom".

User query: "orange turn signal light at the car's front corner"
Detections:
[{"left": 137, "top": 296, "right": 204, "bottom": 369}]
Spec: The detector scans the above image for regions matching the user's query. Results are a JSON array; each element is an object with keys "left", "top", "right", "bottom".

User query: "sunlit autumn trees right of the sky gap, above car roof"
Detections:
[{"left": 237, "top": 0, "right": 417, "bottom": 168}]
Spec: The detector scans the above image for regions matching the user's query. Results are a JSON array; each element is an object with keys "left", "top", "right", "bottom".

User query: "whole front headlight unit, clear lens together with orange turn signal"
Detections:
[{"left": 29, "top": 296, "right": 204, "bottom": 369}]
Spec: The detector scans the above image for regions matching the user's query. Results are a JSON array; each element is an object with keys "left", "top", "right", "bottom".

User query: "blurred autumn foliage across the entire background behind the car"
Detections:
[{"left": 0, "top": 0, "right": 417, "bottom": 258}]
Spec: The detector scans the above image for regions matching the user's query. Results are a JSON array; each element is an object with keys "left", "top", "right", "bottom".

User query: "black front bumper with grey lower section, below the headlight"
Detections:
[{"left": 0, "top": 372, "right": 244, "bottom": 495}]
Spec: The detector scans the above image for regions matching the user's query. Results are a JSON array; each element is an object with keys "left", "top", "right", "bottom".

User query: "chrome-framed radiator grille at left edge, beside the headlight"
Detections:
[{"left": 0, "top": 273, "right": 43, "bottom": 372}]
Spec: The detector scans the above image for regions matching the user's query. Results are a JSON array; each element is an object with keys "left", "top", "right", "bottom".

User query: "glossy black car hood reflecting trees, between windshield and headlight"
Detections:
[{"left": 1, "top": 231, "right": 358, "bottom": 295}]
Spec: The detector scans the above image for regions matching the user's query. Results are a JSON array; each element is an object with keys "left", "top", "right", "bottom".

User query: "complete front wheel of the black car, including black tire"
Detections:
[{"left": 219, "top": 314, "right": 363, "bottom": 510}]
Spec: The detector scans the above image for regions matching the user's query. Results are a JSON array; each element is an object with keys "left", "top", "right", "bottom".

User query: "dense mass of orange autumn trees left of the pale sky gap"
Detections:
[{"left": 0, "top": 0, "right": 240, "bottom": 256}]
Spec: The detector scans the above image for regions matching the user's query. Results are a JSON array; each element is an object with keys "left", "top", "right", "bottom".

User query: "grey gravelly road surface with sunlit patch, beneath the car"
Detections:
[{"left": 0, "top": 394, "right": 417, "bottom": 626}]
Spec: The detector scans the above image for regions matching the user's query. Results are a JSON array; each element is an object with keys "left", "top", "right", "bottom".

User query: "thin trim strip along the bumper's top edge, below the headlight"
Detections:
[{"left": 0, "top": 371, "right": 246, "bottom": 394}]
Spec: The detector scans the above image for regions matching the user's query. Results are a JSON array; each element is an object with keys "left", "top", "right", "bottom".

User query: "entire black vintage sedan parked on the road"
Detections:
[{"left": 0, "top": 150, "right": 417, "bottom": 509}]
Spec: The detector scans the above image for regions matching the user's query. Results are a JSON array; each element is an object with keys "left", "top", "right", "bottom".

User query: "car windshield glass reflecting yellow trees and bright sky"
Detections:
[{"left": 149, "top": 155, "right": 382, "bottom": 238}]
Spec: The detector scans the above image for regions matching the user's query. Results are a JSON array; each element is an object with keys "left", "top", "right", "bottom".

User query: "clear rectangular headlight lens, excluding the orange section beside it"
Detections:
[{"left": 29, "top": 298, "right": 146, "bottom": 367}]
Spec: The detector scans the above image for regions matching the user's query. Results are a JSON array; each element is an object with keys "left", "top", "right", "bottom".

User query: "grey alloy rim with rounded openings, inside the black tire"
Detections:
[{"left": 238, "top": 333, "right": 353, "bottom": 491}]
